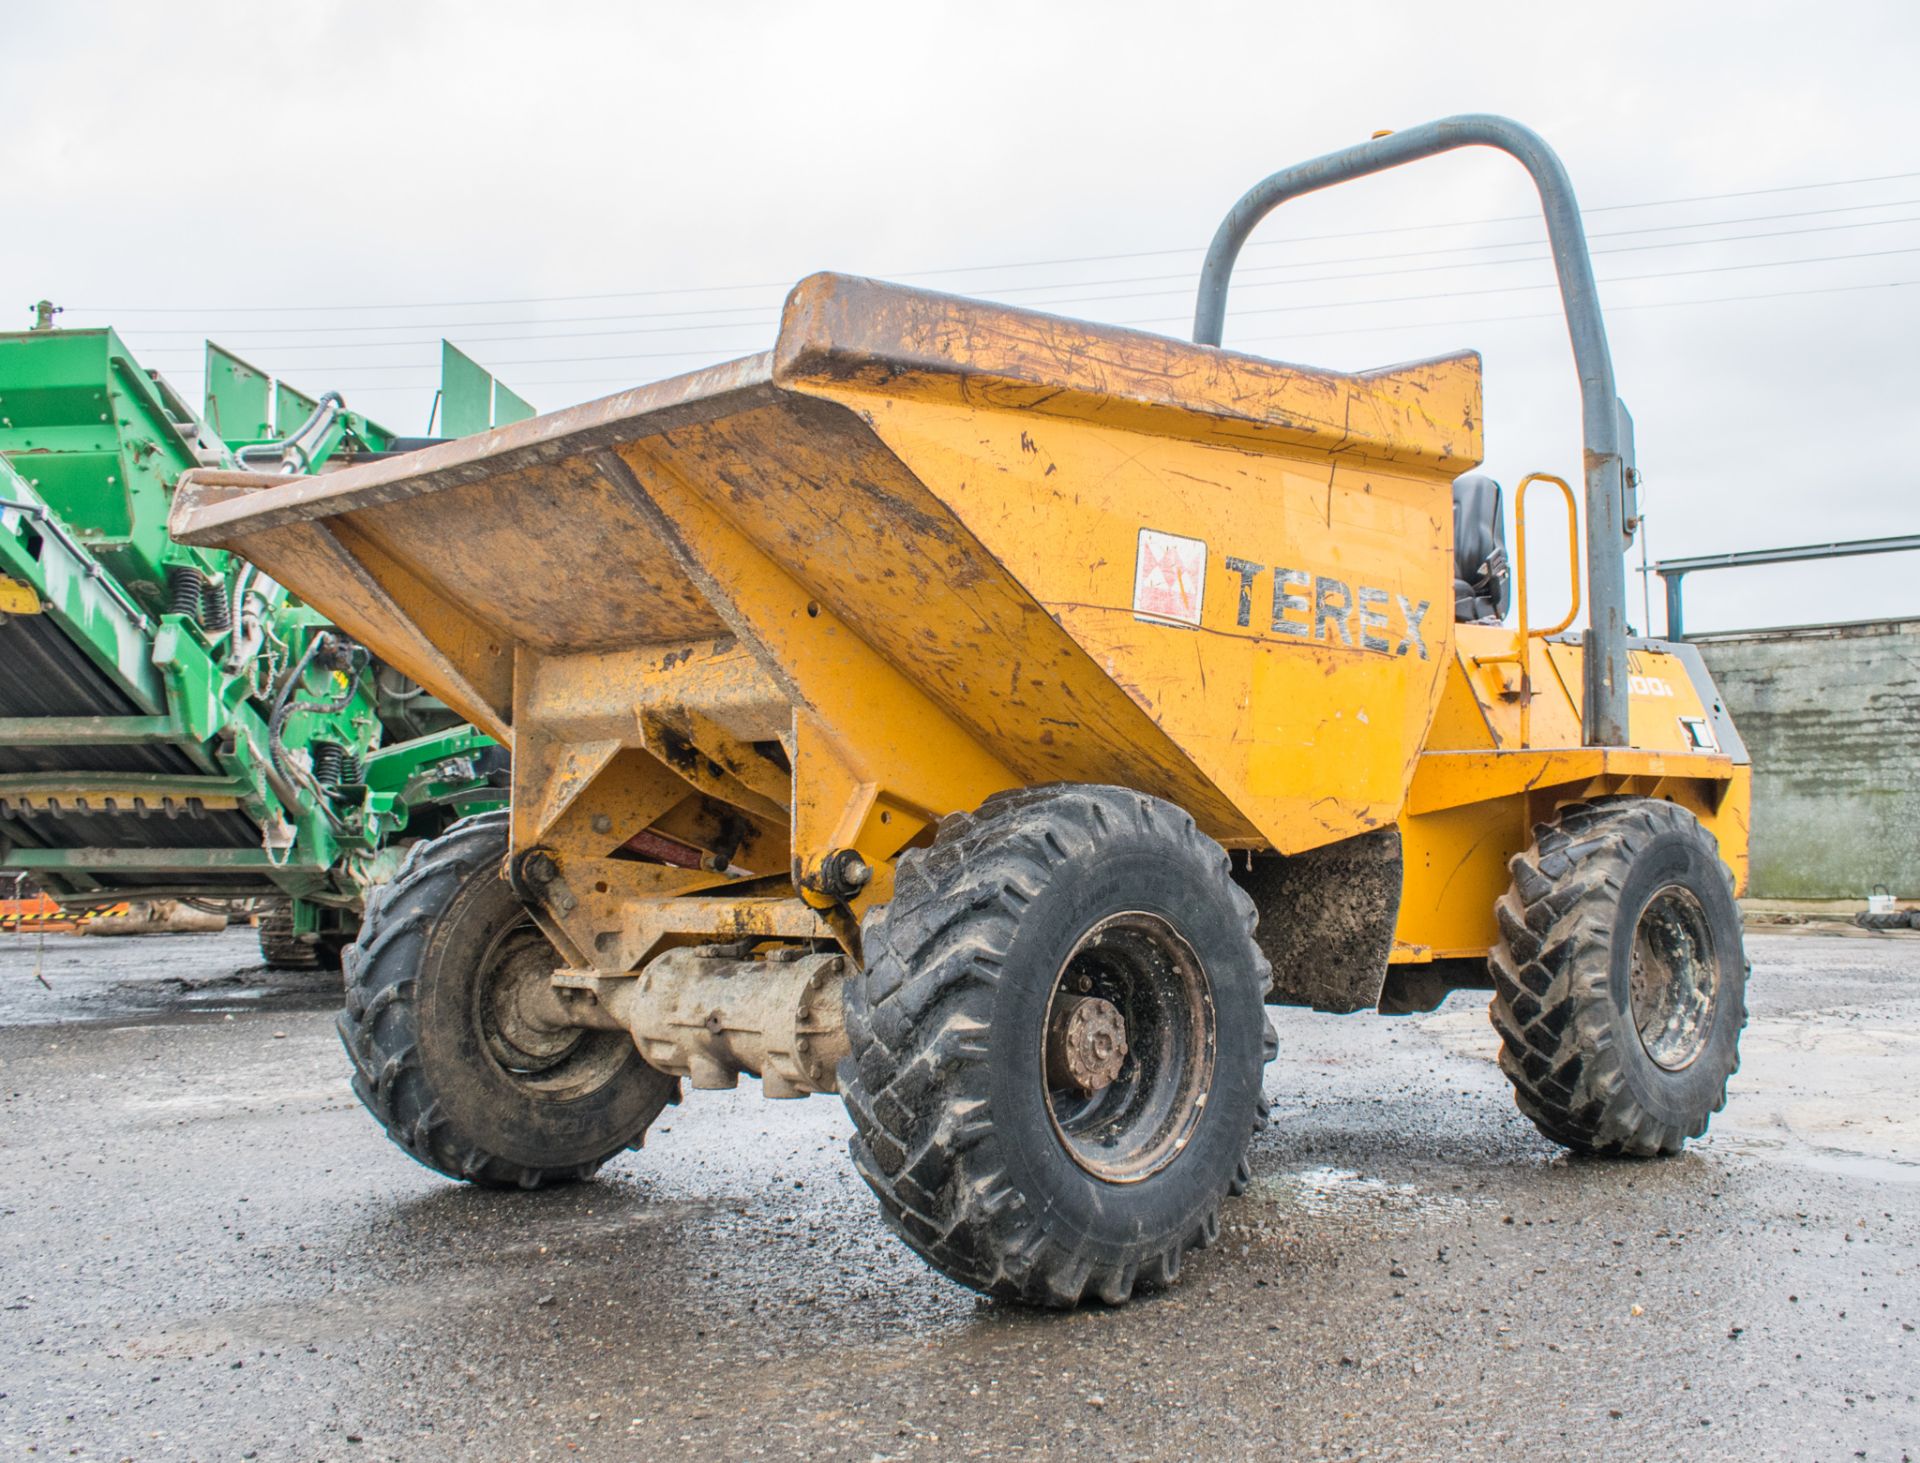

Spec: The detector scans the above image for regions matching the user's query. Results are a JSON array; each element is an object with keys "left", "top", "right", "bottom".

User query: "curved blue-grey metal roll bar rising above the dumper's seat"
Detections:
[{"left": 1194, "top": 113, "right": 1638, "bottom": 747}]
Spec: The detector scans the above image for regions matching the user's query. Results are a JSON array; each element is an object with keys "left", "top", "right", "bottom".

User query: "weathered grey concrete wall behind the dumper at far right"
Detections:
[{"left": 1690, "top": 620, "right": 1920, "bottom": 899}]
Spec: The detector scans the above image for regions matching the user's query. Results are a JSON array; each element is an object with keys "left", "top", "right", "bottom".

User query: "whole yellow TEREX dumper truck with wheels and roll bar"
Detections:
[{"left": 173, "top": 117, "right": 1749, "bottom": 1306}]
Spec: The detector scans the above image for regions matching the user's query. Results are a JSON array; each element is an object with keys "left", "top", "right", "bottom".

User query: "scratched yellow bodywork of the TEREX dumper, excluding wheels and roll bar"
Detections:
[{"left": 175, "top": 276, "right": 1749, "bottom": 970}]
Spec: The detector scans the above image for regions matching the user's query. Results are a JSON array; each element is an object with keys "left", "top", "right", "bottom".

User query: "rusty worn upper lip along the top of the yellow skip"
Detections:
[{"left": 169, "top": 275, "right": 1478, "bottom": 547}]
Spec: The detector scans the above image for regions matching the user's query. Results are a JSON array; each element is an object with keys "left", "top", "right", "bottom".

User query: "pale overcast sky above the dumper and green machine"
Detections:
[{"left": 0, "top": 0, "right": 1920, "bottom": 630}]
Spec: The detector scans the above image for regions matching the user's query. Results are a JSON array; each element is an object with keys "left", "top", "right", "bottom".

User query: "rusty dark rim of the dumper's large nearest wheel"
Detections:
[{"left": 1041, "top": 910, "right": 1213, "bottom": 1183}]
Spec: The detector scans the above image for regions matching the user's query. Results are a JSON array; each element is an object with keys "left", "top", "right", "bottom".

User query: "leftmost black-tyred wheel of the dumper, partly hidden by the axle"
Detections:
[{"left": 340, "top": 808, "right": 678, "bottom": 1188}]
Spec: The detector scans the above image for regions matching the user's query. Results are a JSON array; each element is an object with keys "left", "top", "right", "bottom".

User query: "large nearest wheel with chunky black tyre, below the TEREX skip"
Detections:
[{"left": 841, "top": 785, "right": 1275, "bottom": 1306}]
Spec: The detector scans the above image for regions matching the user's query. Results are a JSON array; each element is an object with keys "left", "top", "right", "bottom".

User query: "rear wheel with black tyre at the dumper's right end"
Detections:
[{"left": 1488, "top": 799, "right": 1747, "bottom": 1158}]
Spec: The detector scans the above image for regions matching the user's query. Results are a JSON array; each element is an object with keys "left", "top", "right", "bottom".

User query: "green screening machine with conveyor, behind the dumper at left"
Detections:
[{"left": 0, "top": 305, "right": 532, "bottom": 968}]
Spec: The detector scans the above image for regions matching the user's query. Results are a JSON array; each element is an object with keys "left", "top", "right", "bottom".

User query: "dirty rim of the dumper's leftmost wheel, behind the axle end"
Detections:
[{"left": 474, "top": 920, "right": 634, "bottom": 1102}]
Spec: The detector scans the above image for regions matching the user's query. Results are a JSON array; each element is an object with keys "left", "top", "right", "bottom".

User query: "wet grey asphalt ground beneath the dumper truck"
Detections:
[{"left": 0, "top": 929, "right": 1920, "bottom": 1459}]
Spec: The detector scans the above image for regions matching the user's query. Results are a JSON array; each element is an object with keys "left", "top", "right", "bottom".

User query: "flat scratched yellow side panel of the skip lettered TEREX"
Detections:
[{"left": 787, "top": 359, "right": 1476, "bottom": 852}]
